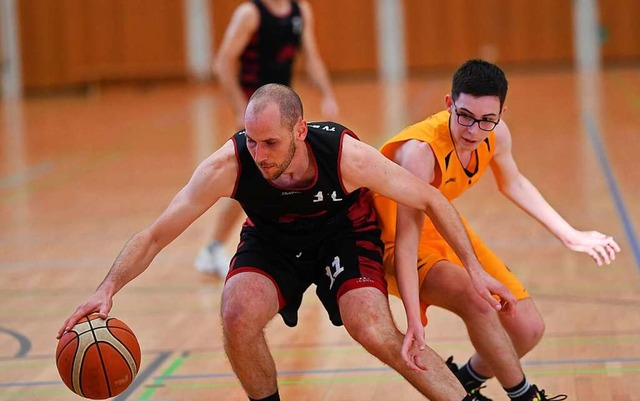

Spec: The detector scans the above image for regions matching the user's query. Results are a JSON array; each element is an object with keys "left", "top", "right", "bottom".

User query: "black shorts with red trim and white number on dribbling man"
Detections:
[{"left": 227, "top": 226, "right": 387, "bottom": 327}]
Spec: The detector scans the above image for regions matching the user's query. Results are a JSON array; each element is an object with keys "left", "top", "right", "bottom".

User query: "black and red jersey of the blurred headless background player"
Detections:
[{"left": 240, "top": 0, "right": 303, "bottom": 98}]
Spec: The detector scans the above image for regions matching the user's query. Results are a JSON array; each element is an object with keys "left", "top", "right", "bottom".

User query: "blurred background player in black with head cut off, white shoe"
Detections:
[{"left": 194, "top": 0, "right": 338, "bottom": 277}]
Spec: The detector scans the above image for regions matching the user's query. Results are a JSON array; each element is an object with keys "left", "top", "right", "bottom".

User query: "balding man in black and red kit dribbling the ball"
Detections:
[{"left": 58, "top": 84, "right": 515, "bottom": 401}]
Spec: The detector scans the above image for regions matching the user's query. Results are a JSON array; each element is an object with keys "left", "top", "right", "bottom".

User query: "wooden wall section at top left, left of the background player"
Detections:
[{"left": 18, "top": 0, "right": 186, "bottom": 90}]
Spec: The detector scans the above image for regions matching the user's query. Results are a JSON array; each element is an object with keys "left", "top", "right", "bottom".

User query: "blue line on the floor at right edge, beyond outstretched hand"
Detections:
[{"left": 584, "top": 115, "right": 640, "bottom": 273}]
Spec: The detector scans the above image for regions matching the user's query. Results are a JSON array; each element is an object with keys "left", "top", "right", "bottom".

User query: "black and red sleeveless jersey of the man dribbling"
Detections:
[{"left": 232, "top": 122, "right": 378, "bottom": 250}]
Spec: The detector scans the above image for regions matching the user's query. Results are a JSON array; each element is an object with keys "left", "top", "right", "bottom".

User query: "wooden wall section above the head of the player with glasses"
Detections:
[{"left": 404, "top": 0, "right": 573, "bottom": 69}]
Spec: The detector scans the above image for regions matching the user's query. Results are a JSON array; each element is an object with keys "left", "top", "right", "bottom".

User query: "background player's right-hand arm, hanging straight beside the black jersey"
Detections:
[{"left": 298, "top": 1, "right": 338, "bottom": 119}]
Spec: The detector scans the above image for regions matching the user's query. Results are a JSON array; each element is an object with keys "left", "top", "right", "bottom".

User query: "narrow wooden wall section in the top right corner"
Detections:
[{"left": 599, "top": 0, "right": 640, "bottom": 61}]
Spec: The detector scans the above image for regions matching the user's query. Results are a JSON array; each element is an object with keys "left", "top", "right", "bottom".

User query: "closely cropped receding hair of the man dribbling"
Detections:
[{"left": 249, "top": 84, "right": 303, "bottom": 129}]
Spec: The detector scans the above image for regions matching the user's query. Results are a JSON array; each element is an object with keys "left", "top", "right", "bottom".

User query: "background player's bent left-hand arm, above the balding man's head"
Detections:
[{"left": 215, "top": 2, "right": 260, "bottom": 127}]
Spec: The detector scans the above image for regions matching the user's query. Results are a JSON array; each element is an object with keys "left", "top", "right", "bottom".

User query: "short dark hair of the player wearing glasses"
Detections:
[{"left": 451, "top": 59, "right": 508, "bottom": 108}]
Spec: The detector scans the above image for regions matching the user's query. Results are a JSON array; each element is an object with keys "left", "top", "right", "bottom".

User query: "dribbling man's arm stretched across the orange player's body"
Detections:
[{"left": 341, "top": 136, "right": 516, "bottom": 310}]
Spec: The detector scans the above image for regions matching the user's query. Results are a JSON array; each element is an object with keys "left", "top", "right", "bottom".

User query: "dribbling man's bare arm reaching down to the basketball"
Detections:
[{"left": 58, "top": 141, "right": 238, "bottom": 338}]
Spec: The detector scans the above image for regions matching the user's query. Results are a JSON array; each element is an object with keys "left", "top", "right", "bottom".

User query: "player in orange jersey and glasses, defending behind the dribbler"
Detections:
[{"left": 374, "top": 60, "right": 620, "bottom": 401}]
